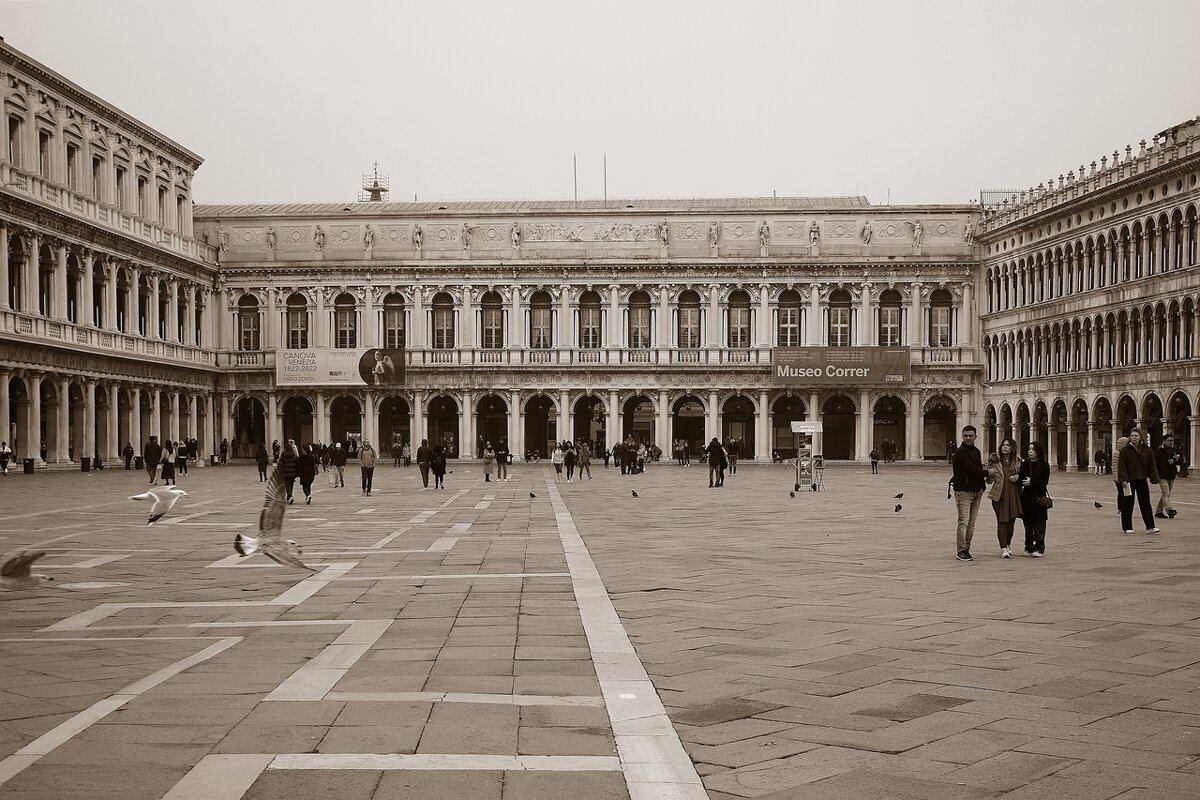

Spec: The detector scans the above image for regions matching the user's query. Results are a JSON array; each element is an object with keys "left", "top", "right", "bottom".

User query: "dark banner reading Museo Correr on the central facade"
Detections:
[{"left": 770, "top": 347, "right": 912, "bottom": 386}]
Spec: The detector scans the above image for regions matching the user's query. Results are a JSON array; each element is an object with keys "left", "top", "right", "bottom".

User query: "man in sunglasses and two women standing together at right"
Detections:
[{"left": 948, "top": 425, "right": 1054, "bottom": 561}]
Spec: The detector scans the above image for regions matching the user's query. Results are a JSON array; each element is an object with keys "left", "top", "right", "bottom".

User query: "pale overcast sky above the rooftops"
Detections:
[{"left": 9, "top": 0, "right": 1200, "bottom": 208}]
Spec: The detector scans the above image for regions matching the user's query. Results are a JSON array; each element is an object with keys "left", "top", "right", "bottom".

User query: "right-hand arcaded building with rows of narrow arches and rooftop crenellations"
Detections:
[{"left": 979, "top": 118, "right": 1200, "bottom": 467}]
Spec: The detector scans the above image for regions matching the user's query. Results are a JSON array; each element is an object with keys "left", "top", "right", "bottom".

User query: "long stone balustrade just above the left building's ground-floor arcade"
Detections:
[{"left": 0, "top": 311, "right": 216, "bottom": 366}]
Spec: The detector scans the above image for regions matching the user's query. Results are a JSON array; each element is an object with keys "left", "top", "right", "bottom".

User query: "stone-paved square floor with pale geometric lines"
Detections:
[{"left": 0, "top": 464, "right": 1200, "bottom": 800}]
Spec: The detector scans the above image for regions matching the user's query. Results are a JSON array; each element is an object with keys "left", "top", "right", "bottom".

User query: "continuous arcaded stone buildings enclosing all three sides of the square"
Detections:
[{"left": 0, "top": 37, "right": 1200, "bottom": 467}]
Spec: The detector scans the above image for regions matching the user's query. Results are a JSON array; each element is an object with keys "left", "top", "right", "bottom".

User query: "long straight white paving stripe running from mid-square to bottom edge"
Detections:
[{"left": 546, "top": 480, "right": 708, "bottom": 800}]
